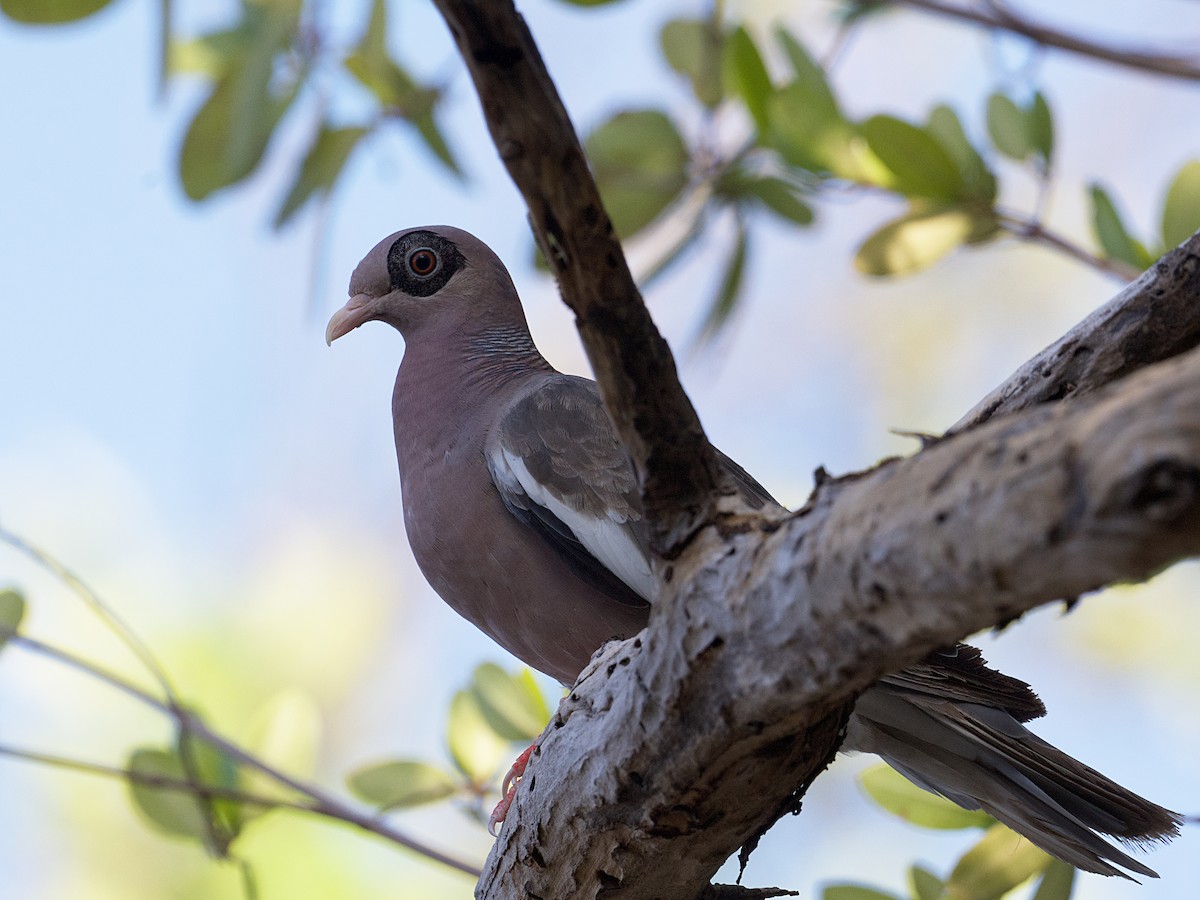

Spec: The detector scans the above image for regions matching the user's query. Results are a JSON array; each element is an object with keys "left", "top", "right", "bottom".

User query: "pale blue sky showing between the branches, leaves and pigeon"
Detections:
[{"left": 0, "top": 0, "right": 1200, "bottom": 898}]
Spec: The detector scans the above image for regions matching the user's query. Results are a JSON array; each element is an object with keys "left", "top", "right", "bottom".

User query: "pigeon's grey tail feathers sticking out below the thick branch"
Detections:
[{"left": 844, "top": 648, "right": 1181, "bottom": 878}]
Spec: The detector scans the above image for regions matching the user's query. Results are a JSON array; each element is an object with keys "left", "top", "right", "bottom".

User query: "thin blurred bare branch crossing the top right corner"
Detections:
[{"left": 884, "top": 0, "right": 1200, "bottom": 80}]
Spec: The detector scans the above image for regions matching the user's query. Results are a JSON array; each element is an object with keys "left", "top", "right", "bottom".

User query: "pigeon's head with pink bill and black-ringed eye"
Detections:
[{"left": 325, "top": 226, "right": 520, "bottom": 343}]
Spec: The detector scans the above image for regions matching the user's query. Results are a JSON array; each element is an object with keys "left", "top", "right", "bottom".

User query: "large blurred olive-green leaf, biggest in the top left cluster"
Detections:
[{"left": 179, "top": 0, "right": 300, "bottom": 200}]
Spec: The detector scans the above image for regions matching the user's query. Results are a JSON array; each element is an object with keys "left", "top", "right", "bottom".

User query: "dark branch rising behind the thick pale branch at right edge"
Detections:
[{"left": 950, "top": 232, "right": 1200, "bottom": 433}]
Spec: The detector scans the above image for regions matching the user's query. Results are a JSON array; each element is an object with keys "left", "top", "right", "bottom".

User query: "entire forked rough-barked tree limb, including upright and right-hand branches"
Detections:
[{"left": 424, "top": 0, "right": 1200, "bottom": 900}]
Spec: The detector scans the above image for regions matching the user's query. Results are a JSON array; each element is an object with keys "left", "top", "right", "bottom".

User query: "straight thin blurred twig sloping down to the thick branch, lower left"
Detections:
[{"left": 0, "top": 626, "right": 479, "bottom": 878}]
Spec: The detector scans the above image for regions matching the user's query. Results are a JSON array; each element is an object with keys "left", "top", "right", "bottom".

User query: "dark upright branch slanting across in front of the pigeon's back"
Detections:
[{"left": 434, "top": 0, "right": 716, "bottom": 552}]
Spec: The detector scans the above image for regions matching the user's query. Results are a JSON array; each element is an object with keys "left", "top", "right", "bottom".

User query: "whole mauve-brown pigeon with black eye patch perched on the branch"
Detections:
[{"left": 325, "top": 227, "right": 1180, "bottom": 876}]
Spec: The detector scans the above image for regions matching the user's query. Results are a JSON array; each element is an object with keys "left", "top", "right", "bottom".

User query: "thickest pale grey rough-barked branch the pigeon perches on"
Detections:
[{"left": 480, "top": 340, "right": 1200, "bottom": 898}]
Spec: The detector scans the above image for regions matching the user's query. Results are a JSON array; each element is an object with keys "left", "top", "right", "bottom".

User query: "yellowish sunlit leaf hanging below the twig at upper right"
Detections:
[{"left": 854, "top": 208, "right": 980, "bottom": 277}]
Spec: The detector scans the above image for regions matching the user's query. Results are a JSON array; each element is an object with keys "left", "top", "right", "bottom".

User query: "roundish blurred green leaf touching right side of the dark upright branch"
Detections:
[{"left": 584, "top": 109, "right": 688, "bottom": 238}]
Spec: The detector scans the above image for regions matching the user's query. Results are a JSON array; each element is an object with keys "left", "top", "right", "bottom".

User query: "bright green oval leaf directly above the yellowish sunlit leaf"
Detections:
[{"left": 860, "top": 115, "right": 965, "bottom": 200}]
